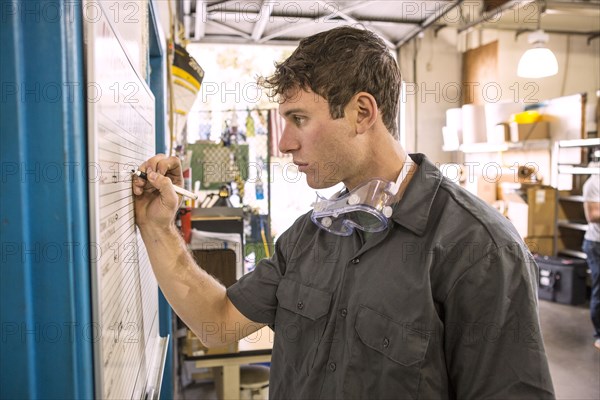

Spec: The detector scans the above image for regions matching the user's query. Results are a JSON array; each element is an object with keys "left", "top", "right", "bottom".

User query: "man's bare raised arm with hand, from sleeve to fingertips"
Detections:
[{"left": 133, "top": 155, "right": 263, "bottom": 347}]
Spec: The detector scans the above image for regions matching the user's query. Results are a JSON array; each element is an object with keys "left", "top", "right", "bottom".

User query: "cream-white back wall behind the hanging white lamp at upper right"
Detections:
[{"left": 399, "top": 28, "right": 600, "bottom": 167}]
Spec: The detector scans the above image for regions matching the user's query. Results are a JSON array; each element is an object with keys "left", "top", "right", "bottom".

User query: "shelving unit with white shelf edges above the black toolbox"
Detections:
[{"left": 554, "top": 138, "right": 600, "bottom": 259}]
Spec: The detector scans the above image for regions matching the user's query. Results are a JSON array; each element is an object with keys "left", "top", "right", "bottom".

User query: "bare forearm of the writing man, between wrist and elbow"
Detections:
[{"left": 140, "top": 226, "right": 233, "bottom": 346}]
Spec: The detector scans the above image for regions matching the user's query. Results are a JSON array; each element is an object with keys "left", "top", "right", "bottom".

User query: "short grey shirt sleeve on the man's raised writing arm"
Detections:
[{"left": 227, "top": 234, "right": 285, "bottom": 325}]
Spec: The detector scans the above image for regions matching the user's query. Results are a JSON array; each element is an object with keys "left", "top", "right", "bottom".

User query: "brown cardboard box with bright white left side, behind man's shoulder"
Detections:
[{"left": 505, "top": 186, "right": 556, "bottom": 238}]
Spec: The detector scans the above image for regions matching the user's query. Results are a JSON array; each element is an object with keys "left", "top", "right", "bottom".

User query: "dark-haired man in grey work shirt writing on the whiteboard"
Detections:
[{"left": 133, "top": 27, "right": 554, "bottom": 399}]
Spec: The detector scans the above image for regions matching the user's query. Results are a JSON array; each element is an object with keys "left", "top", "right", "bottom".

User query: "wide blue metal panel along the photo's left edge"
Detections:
[{"left": 0, "top": 0, "right": 97, "bottom": 399}]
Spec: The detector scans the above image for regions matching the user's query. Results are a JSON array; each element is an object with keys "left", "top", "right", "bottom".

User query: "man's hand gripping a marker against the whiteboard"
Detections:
[{"left": 133, "top": 154, "right": 183, "bottom": 228}]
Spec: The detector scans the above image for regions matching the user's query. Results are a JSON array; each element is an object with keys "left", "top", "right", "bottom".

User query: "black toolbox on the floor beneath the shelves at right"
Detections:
[{"left": 535, "top": 255, "right": 587, "bottom": 305}]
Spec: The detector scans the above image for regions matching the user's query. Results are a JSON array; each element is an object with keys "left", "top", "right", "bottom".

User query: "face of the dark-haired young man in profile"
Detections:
[{"left": 279, "top": 90, "right": 356, "bottom": 189}]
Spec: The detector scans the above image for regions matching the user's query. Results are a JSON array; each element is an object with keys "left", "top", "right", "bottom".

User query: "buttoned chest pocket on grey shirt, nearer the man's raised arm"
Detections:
[{"left": 273, "top": 279, "right": 332, "bottom": 374}]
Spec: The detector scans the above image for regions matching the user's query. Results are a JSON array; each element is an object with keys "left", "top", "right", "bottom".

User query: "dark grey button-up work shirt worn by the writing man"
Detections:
[{"left": 227, "top": 154, "right": 554, "bottom": 399}]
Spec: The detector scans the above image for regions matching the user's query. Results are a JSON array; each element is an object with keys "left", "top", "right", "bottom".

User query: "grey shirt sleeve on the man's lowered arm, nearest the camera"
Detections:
[{"left": 444, "top": 244, "right": 554, "bottom": 399}]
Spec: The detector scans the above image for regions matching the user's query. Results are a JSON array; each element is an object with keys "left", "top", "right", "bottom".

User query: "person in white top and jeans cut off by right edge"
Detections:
[{"left": 583, "top": 156, "right": 600, "bottom": 350}]
